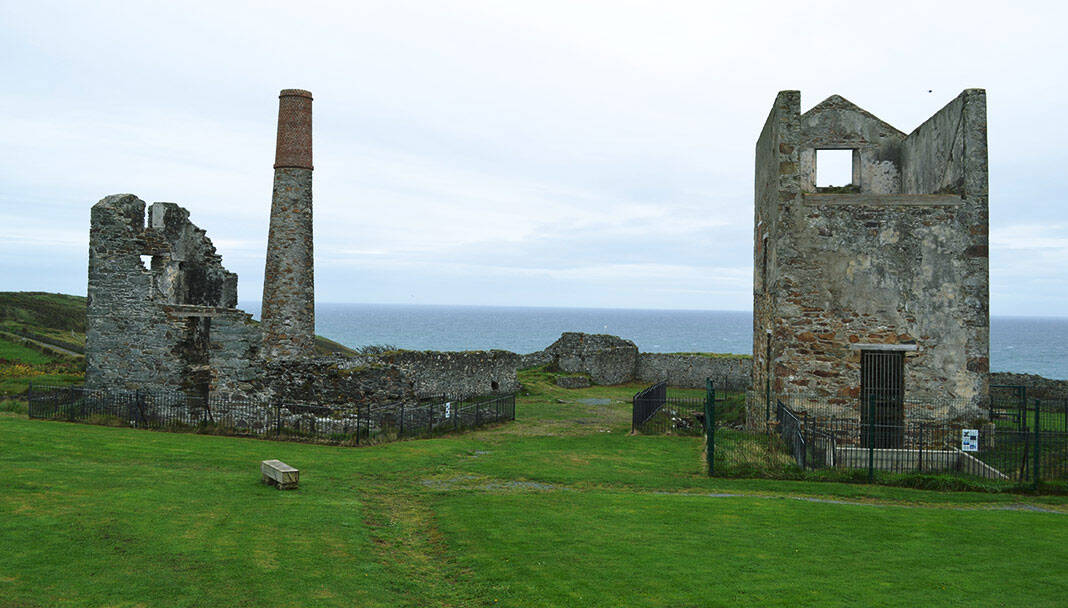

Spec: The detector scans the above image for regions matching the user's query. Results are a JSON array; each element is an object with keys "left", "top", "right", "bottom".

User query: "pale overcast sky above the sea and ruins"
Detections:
[{"left": 0, "top": 0, "right": 1068, "bottom": 315}]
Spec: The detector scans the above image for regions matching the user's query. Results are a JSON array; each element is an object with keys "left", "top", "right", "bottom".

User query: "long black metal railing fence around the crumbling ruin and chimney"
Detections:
[{"left": 27, "top": 386, "right": 516, "bottom": 446}]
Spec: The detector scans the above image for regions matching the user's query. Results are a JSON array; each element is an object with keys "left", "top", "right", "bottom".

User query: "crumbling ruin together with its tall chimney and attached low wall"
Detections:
[{"left": 85, "top": 89, "right": 519, "bottom": 407}]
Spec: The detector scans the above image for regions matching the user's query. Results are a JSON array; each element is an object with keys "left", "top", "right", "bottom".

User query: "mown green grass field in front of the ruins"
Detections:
[{"left": 0, "top": 372, "right": 1068, "bottom": 607}]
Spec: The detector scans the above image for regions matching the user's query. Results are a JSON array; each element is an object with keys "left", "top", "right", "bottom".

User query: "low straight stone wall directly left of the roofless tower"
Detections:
[{"left": 637, "top": 353, "right": 752, "bottom": 389}]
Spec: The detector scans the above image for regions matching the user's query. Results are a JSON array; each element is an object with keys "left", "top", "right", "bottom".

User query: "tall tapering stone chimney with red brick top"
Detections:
[{"left": 261, "top": 89, "right": 315, "bottom": 359}]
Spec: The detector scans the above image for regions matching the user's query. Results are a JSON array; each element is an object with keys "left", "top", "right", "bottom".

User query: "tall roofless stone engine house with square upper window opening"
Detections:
[{"left": 749, "top": 89, "right": 990, "bottom": 425}]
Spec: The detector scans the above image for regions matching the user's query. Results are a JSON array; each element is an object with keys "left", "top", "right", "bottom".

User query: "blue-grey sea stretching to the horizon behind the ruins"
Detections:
[{"left": 240, "top": 302, "right": 1068, "bottom": 379}]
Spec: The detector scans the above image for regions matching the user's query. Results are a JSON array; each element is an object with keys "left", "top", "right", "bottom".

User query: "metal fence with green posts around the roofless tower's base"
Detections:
[{"left": 709, "top": 394, "right": 1068, "bottom": 485}]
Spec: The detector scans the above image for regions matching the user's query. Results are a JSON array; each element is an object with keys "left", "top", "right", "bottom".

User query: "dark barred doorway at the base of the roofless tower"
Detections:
[{"left": 861, "top": 350, "right": 905, "bottom": 448}]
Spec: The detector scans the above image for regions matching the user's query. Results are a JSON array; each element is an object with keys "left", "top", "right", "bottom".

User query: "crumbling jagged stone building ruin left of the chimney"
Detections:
[{"left": 85, "top": 194, "right": 260, "bottom": 396}]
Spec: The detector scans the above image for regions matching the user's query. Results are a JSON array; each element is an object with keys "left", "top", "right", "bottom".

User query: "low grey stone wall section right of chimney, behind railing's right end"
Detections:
[{"left": 377, "top": 350, "right": 520, "bottom": 399}]
